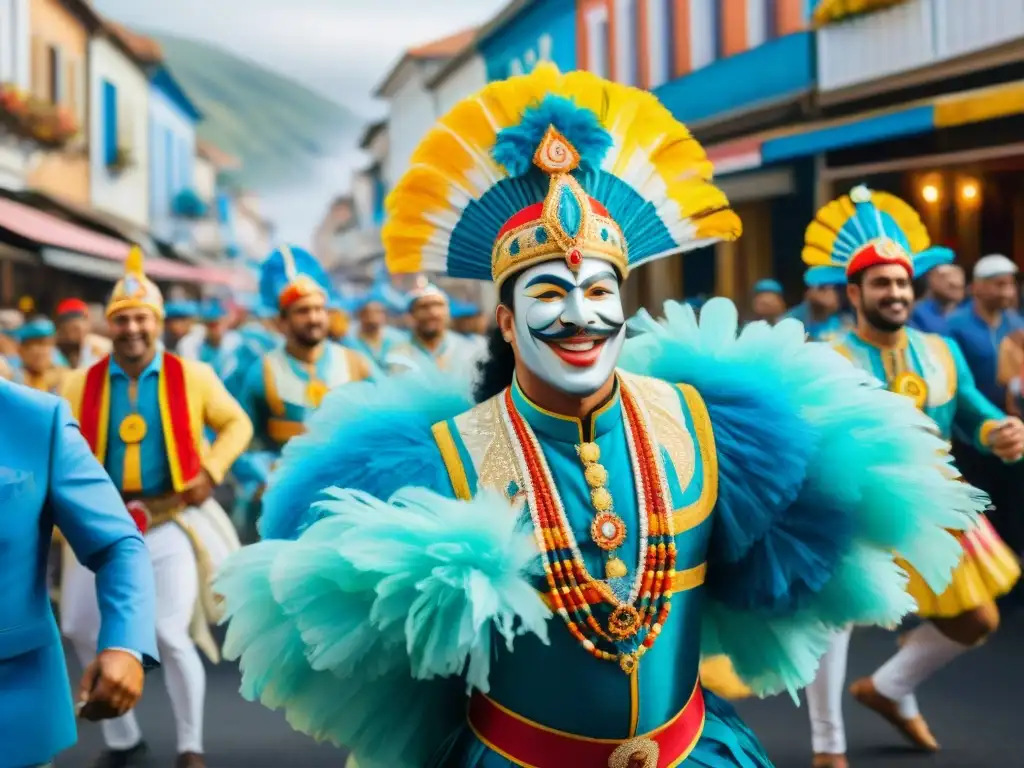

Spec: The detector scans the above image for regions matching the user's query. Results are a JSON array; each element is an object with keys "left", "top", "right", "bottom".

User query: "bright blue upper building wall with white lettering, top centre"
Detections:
[{"left": 479, "top": 0, "right": 578, "bottom": 80}]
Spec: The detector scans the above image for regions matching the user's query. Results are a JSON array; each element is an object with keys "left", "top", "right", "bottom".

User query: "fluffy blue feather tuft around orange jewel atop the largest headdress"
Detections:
[{"left": 490, "top": 96, "right": 612, "bottom": 177}]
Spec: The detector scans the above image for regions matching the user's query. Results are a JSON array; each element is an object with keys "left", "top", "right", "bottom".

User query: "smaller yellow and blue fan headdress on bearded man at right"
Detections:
[{"left": 803, "top": 185, "right": 954, "bottom": 286}]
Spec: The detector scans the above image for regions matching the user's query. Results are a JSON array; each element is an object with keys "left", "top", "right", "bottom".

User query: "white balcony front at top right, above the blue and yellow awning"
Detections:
[{"left": 817, "top": 0, "right": 1024, "bottom": 92}]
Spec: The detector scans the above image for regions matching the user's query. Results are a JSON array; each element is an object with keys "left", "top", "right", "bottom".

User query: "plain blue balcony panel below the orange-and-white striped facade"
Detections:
[{"left": 654, "top": 32, "right": 814, "bottom": 128}]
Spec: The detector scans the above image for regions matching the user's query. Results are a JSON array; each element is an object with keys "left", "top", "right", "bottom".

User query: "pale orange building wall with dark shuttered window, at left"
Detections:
[{"left": 29, "top": 0, "right": 90, "bottom": 205}]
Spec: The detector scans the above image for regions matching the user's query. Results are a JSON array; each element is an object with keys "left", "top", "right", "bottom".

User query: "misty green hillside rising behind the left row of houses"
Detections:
[{"left": 146, "top": 33, "right": 362, "bottom": 188}]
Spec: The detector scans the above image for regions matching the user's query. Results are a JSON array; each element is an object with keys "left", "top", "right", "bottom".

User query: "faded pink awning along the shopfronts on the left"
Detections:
[{"left": 0, "top": 198, "right": 250, "bottom": 286}]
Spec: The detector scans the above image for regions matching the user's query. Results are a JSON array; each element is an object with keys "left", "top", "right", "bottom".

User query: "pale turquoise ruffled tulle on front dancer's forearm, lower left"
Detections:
[{"left": 215, "top": 488, "right": 550, "bottom": 768}]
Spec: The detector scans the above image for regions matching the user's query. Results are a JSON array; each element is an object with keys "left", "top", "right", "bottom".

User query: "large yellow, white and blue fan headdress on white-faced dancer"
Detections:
[{"left": 383, "top": 63, "right": 740, "bottom": 284}]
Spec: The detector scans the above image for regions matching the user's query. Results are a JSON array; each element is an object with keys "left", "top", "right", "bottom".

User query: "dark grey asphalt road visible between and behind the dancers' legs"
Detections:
[{"left": 57, "top": 611, "right": 1024, "bottom": 768}]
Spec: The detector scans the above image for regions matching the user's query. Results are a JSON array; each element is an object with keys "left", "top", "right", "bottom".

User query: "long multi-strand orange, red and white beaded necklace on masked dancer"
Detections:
[{"left": 501, "top": 383, "right": 676, "bottom": 674}]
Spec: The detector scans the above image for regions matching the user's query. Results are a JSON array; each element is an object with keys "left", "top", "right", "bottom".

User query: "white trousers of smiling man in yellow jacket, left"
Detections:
[{"left": 60, "top": 523, "right": 206, "bottom": 754}]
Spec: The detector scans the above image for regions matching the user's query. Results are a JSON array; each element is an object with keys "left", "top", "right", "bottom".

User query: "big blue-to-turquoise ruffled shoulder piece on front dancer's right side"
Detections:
[{"left": 622, "top": 298, "right": 986, "bottom": 694}]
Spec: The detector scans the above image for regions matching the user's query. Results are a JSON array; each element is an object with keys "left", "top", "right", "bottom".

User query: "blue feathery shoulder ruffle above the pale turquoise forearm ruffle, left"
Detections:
[{"left": 259, "top": 371, "right": 474, "bottom": 539}]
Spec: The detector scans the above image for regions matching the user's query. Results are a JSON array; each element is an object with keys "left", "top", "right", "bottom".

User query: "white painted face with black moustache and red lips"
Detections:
[{"left": 513, "top": 258, "right": 626, "bottom": 395}]
